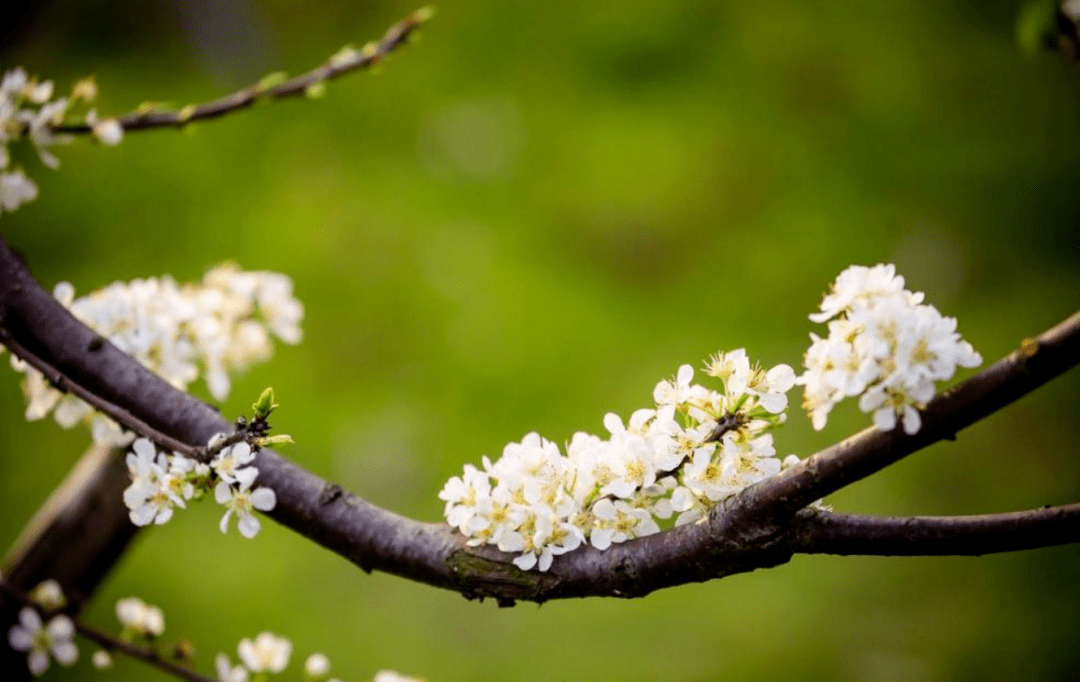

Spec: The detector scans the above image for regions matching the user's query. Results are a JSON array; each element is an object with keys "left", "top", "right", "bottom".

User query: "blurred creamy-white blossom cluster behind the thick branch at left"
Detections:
[{"left": 12, "top": 264, "right": 303, "bottom": 445}]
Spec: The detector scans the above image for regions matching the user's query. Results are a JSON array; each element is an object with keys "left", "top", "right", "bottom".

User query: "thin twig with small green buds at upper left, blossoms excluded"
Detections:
[{"left": 53, "top": 8, "right": 432, "bottom": 133}]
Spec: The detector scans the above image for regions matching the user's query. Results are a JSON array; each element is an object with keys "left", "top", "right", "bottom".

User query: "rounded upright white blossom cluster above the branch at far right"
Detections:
[{"left": 798, "top": 264, "right": 983, "bottom": 434}]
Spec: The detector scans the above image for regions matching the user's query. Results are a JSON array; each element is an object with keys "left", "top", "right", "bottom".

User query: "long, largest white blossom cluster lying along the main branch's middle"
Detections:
[{"left": 438, "top": 349, "right": 798, "bottom": 571}]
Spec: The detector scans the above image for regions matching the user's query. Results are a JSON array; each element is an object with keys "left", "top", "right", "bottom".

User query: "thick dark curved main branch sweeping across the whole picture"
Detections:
[{"left": 0, "top": 232, "right": 1080, "bottom": 604}]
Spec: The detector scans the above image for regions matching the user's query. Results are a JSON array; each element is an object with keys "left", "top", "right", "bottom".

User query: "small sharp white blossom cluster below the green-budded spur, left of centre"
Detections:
[{"left": 124, "top": 433, "right": 278, "bottom": 538}]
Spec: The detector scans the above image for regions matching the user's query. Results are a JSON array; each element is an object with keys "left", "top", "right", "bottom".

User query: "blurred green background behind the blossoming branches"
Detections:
[{"left": 0, "top": 0, "right": 1080, "bottom": 682}]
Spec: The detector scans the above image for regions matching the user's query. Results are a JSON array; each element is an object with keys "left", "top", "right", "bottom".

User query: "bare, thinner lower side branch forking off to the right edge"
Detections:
[{"left": 792, "top": 504, "right": 1080, "bottom": 557}]
